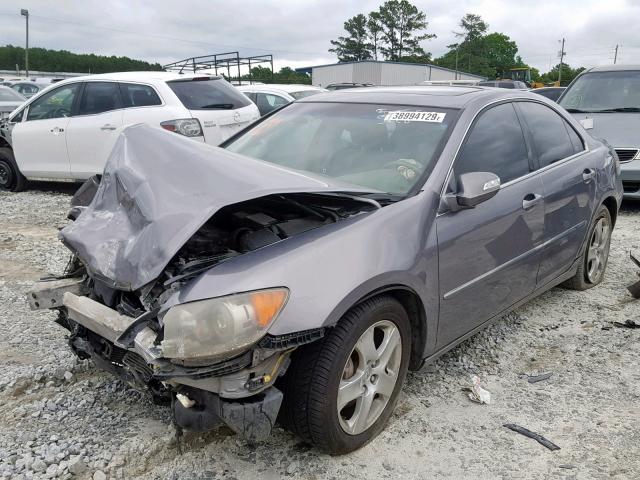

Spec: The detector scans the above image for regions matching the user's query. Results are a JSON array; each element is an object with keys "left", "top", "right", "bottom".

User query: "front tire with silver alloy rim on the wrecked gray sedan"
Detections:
[{"left": 283, "top": 295, "right": 411, "bottom": 455}]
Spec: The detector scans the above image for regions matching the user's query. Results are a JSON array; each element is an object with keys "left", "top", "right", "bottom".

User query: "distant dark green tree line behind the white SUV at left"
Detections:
[{"left": 0, "top": 45, "right": 162, "bottom": 73}]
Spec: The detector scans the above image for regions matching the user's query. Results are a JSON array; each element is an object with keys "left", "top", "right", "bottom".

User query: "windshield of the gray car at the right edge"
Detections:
[{"left": 560, "top": 71, "right": 640, "bottom": 112}]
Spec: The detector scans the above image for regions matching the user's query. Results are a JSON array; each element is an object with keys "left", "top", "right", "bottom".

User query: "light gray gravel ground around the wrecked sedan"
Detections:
[{"left": 0, "top": 184, "right": 640, "bottom": 480}]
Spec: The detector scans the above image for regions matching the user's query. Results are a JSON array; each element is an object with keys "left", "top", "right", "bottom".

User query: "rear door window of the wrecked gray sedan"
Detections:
[{"left": 518, "top": 102, "right": 574, "bottom": 168}]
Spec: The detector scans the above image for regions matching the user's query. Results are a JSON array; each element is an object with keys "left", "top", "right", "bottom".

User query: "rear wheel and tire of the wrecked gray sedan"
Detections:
[{"left": 562, "top": 205, "right": 613, "bottom": 290}]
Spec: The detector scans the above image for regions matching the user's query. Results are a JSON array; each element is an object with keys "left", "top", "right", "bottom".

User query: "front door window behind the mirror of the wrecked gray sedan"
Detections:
[{"left": 454, "top": 103, "right": 530, "bottom": 184}]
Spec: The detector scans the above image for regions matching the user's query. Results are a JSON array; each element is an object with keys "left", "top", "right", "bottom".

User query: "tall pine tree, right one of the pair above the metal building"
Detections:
[{"left": 379, "top": 0, "right": 435, "bottom": 61}]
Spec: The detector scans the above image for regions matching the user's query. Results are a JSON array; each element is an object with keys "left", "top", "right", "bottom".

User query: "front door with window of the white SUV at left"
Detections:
[{"left": 12, "top": 83, "right": 80, "bottom": 178}]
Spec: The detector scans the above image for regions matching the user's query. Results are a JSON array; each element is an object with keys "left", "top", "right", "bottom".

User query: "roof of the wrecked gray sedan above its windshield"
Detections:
[{"left": 297, "top": 85, "right": 539, "bottom": 108}]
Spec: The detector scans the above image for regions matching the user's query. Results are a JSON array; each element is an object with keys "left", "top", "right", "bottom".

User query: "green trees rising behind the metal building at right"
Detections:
[{"left": 329, "top": 0, "right": 584, "bottom": 85}]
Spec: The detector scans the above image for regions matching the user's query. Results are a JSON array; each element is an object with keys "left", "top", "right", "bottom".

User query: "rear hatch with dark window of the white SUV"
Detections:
[{"left": 167, "top": 76, "right": 260, "bottom": 145}]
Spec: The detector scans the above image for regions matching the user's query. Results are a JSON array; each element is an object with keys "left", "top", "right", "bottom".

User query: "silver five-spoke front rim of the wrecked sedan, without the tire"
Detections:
[{"left": 337, "top": 320, "right": 402, "bottom": 435}]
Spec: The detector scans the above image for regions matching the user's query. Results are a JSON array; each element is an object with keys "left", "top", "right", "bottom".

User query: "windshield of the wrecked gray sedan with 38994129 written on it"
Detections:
[{"left": 226, "top": 102, "right": 456, "bottom": 195}]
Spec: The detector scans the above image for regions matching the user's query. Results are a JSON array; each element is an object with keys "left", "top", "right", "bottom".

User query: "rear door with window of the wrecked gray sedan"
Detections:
[{"left": 516, "top": 101, "right": 598, "bottom": 285}]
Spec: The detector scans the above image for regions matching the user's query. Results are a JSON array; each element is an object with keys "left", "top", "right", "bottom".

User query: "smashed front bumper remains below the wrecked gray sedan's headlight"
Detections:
[{"left": 28, "top": 278, "right": 322, "bottom": 441}]
